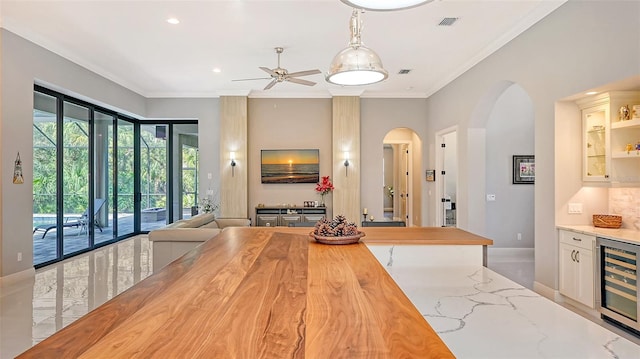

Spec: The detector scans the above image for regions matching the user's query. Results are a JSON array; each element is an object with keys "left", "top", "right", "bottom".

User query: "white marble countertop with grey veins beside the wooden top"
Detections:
[{"left": 387, "top": 263, "right": 640, "bottom": 359}]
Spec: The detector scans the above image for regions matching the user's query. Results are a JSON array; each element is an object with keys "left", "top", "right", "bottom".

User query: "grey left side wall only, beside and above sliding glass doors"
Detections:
[{"left": 0, "top": 29, "right": 146, "bottom": 276}]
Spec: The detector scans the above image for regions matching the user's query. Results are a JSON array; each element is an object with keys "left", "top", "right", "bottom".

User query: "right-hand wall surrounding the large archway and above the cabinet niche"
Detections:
[{"left": 426, "top": 1, "right": 640, "bottom": 288}]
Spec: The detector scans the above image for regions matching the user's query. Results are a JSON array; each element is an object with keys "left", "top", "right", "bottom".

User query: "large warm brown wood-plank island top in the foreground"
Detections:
[{"left": 19, "top": 227, "right": 460, "bottom": 358}]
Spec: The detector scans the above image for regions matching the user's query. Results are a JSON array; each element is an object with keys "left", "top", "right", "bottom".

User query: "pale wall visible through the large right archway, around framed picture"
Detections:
[{"left": 484, "top": 85, "right": 534, "bottom": 248}]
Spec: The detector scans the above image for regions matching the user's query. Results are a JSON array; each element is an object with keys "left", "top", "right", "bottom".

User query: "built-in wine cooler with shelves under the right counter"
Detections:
[{"left": 596, "top": 237, "right": 640, "bottom": 333}]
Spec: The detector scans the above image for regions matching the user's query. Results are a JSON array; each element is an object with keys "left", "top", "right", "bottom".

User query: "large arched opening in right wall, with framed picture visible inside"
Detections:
[{"left": 467, "top": 81, "right": 535, "bottom": 288}]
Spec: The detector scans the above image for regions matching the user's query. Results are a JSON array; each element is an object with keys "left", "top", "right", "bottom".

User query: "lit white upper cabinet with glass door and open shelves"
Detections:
[{"left": 577, "top": 91, "right": 640, "bottom": 186}]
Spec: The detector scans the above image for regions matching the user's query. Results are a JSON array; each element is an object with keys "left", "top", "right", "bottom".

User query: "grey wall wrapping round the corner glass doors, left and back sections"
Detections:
[{"left": 0, "top": 29, "right": 220, "bottom": 277}]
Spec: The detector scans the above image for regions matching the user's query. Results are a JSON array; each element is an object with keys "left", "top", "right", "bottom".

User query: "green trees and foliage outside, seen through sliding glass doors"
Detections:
[{"left": 33, "top": 120, "right": 172, "bottom": 214}]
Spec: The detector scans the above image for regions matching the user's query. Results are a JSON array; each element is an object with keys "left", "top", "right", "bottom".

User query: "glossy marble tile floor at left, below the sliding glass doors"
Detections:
[{"left": 0, "top": 235, "right": 153, "bottom": 359}]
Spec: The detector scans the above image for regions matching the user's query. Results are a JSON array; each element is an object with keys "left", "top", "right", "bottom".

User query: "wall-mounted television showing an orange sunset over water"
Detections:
[{"left": 260, "top": 149, "right": 320, "bottom": 183}]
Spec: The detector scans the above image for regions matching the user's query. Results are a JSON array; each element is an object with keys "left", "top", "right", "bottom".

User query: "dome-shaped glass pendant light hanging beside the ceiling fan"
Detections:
[{"left": 326, "top": 9, "right": 389, "bottom": 86}]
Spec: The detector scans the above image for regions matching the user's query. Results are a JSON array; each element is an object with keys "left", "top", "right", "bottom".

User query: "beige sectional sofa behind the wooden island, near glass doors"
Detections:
[{"left": 149, "top": 213, "right": 251, "bottom": 273}]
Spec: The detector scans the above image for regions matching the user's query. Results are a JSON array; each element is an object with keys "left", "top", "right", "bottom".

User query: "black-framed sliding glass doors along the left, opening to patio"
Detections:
[{"left": 33, "top": 86, "right": 198, "bottom": 267}]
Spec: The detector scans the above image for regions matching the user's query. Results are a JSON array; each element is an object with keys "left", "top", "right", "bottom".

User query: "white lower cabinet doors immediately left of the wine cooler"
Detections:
[{"left": 559, "top": 230, "right": 596, "bottom": 308}]
